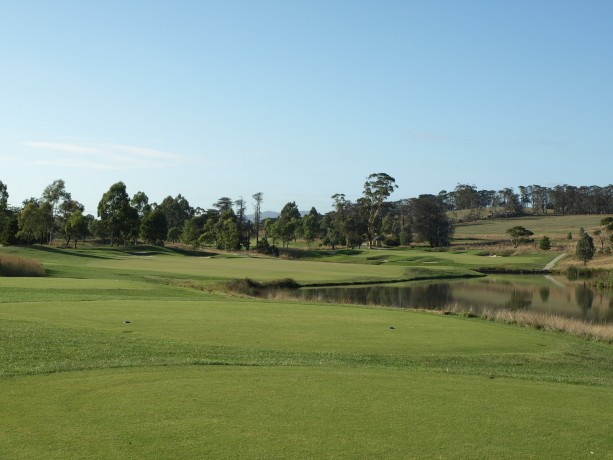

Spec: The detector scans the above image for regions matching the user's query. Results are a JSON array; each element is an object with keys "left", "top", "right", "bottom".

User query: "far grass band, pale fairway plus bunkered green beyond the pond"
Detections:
[{"left": 0, "top": 243, "right": 557, "bottom": 284}]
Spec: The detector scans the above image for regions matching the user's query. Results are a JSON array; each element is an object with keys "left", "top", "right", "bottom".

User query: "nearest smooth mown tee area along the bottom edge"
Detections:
[{"left": 0, "top": 366, "right": 611, "bottom": 459}]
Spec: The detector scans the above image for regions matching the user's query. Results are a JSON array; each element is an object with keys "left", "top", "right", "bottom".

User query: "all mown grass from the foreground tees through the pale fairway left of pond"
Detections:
[{"left": 0, "top": 244, "right": 613, "bottom": 459}]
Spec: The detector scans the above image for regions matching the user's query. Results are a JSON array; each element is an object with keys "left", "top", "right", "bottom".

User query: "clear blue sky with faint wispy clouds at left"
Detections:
[{"left": 0, "top": 0, "right": 613, "bottom": 214}]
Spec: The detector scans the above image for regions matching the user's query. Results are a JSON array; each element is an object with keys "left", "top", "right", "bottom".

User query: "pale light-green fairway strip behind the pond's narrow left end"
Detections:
[{"left": 4, "top": 247, "right": 412, "bottom": 283}]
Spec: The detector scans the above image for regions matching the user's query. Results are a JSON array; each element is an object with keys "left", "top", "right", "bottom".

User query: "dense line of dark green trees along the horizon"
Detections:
[{"left": 0, "top": 177, "right": 613, "bottom": 253}]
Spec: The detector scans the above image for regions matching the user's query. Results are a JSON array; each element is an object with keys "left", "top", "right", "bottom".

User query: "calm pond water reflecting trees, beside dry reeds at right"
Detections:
[{"left": 298, "top": 275, "right": 613, "bottom": 322}]
